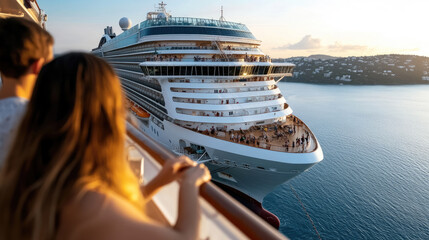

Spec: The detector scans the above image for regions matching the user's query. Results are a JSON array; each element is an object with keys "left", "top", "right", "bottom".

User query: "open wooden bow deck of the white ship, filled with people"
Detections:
[{"left": 182, "top": 115, "right": 317, "bottom": 153}]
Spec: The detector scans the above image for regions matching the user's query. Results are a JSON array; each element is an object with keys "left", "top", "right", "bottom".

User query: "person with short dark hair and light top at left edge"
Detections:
[{"left": 0, "top": 18, "right": 54, "bottom": 167}]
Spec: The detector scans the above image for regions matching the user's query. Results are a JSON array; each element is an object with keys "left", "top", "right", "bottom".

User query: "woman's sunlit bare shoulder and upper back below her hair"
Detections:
[{"left": 57, "top": 191, "right": 179, "bottom": 240}]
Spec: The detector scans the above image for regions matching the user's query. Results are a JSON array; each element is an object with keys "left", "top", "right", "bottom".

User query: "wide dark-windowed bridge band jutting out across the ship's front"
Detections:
[{"left": 141, "top": 66, "right": 293, "bottom": 76}]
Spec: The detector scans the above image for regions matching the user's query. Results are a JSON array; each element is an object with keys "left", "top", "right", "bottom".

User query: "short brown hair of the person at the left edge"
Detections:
[{"left": 0, "top": 18, "right": 54, "bottom": 78}]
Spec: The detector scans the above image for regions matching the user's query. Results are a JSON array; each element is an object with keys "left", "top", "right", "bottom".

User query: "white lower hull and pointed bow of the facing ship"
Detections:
[{"left": 140, "top": 117, "right": 323, "bottom": 203}]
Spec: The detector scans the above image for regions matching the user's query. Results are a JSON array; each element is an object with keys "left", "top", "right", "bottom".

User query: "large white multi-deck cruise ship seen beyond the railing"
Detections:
[{"left": 92, "top": 2, "right": 323, "bottom": 206}]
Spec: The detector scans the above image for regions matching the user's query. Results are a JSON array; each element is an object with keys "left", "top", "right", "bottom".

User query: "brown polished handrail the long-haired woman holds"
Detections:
[{"left": 127, "top": 123, "right": 287, "bottom": 240}]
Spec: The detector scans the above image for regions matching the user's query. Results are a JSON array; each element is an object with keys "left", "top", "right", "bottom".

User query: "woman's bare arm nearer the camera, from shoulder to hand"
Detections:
[{"left": 83, "top": 164, "right": 211, "bottom": 240}]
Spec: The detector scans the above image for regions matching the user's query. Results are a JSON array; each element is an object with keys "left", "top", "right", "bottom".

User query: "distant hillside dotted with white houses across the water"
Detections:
[{"left": 273, "top": 55, "right": 429, "bottom": 85}]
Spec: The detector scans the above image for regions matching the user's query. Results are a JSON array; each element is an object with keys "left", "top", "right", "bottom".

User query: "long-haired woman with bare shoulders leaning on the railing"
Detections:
[{"left": 0, "top": 53, "right": 210, "bottom": 239}]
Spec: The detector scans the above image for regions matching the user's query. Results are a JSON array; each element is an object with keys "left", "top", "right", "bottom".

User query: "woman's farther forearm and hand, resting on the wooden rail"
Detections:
[{"left": 140, "top": 156, "right": 196, "bottom": 201}]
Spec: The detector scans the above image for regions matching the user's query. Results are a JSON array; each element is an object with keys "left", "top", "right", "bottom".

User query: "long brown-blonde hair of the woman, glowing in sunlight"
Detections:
[{"left": 0, "top": 53, "right": 143, "bottom": 239}]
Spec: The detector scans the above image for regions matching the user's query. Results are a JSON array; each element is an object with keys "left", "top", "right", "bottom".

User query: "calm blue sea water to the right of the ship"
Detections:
[{"left": 263, "top": 83, "right": 429, "bottom": 239}]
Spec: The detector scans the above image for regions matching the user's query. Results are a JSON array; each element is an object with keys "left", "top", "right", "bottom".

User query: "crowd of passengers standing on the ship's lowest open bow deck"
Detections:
[{"left": 194, "top": 116, "right": 310, "bottom": 152}]
